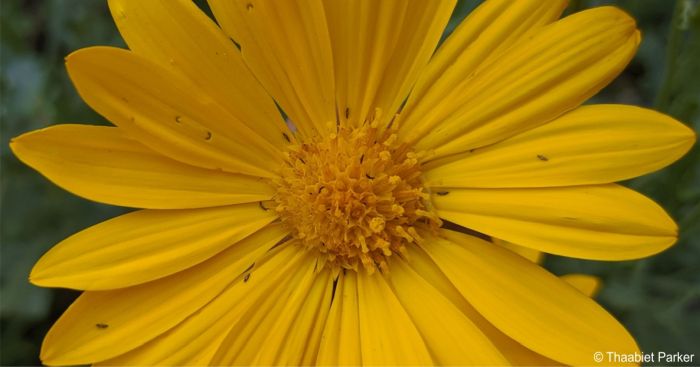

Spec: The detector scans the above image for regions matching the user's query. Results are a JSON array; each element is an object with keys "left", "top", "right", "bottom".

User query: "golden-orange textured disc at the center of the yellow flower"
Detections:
[{"left": 275, "top": 115, "right": 441, "bottom": 273}]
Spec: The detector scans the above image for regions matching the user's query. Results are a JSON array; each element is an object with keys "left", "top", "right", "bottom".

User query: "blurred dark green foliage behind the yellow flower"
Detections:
[{"left": 0, "top": 0, "right": 700, "bottom": 365}]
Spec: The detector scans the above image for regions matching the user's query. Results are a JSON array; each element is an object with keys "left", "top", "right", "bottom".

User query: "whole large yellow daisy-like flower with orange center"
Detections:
[{"left": 11, "top": 0, "right": 695, "bottom": 365}]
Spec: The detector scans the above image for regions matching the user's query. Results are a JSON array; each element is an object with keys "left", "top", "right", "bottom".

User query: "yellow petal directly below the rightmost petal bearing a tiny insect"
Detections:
[{"left": 432, "top": 184, "right": 678, "bottom": 260}]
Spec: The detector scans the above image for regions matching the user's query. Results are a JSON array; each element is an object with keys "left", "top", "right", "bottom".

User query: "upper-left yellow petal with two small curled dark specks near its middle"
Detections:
[{"left": 66, "top": 47, "right": 282, "bottom": 177}]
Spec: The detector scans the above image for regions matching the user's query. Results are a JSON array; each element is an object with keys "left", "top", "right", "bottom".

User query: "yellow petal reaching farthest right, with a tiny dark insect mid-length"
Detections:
[{"left": 425, "top": 105, "right": 695, "bottom": 187}]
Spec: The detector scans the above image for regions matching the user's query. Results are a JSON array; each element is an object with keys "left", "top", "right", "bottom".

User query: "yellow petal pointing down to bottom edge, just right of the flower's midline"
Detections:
[{"left": 358, "top": 271, "right": 433, "bottom": 366}]
